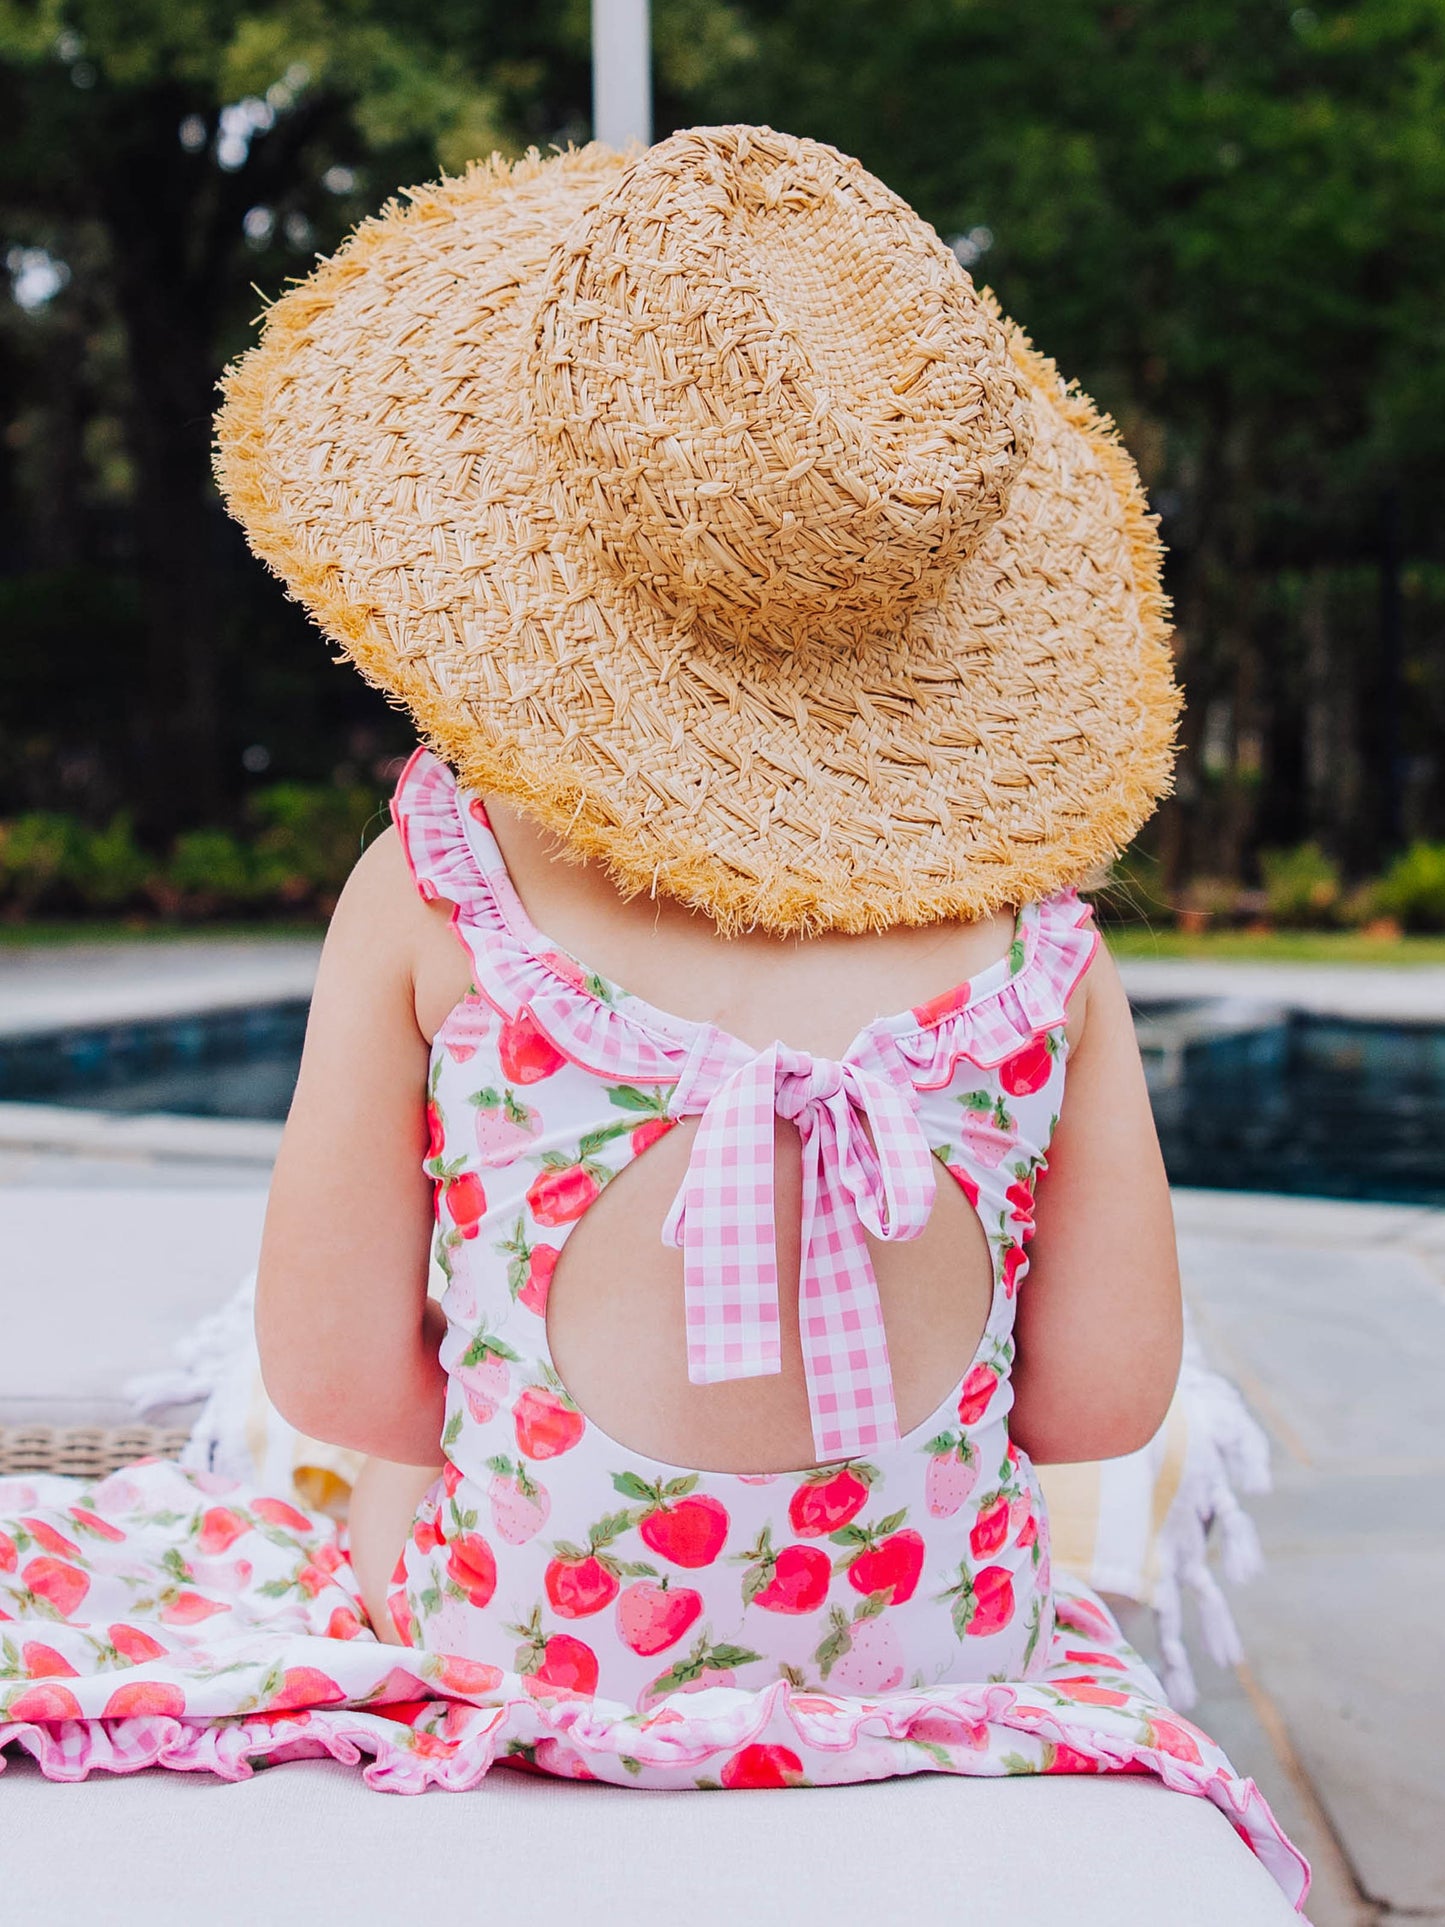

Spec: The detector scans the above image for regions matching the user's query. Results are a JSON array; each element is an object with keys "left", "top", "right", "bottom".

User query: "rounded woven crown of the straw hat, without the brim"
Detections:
[{"left": 530, "top": 127, "right": 1031, "bottom": 644}]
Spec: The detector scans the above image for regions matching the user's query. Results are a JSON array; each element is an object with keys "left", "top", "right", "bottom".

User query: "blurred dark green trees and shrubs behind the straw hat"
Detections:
[{"left": 0, "top": 0, "right": 1445, "bottom": 937}]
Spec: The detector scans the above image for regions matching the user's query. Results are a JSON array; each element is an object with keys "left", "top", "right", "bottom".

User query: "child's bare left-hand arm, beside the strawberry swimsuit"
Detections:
[{"left": 256, "top": 831, "right": 445, "bottom": 1465}]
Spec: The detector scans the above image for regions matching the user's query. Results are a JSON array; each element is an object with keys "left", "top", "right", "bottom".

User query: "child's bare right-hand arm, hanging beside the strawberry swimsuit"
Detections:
[{"left": 1010, "top": 944, "right": 1183, "bottom": 1465}]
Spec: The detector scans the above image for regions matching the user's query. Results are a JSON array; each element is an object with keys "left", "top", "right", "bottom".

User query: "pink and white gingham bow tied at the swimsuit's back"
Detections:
[{"left": 663, "top": 1043, "right": 934, "bottom": 1459}]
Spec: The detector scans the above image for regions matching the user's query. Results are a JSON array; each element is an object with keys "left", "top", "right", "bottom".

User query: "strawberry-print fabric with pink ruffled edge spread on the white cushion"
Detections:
[{"left": 0, "top": 1461, "right": 1308, "bottom": 1908}]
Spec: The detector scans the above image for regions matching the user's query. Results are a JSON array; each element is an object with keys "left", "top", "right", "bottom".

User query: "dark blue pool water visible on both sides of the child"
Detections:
[{"left": 0, "top": 998, "right": 1445, "bottom": 1204}]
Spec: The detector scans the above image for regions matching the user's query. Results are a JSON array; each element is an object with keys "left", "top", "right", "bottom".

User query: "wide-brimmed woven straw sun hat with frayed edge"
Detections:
[{"left": 216, "top": 127, "right": 1177, "bottom": 935}]
